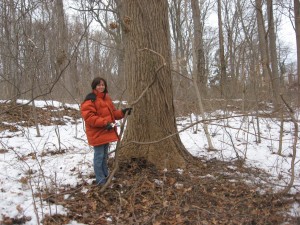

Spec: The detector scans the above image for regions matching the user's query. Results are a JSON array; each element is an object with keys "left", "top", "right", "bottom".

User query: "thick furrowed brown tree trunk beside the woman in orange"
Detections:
[{"left": 120, "top": 0, "right": 190, "bottom": 168}]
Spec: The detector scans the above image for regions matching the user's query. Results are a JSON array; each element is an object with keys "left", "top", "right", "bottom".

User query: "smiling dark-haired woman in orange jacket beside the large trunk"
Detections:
[{"left": 81, "top": 77, "right": 132, "bottom": 185}]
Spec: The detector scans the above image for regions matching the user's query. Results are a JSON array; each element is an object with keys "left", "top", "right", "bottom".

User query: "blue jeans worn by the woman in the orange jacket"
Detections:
[{"left": 94, "top": 144, "right": 109, "bottom": 184}]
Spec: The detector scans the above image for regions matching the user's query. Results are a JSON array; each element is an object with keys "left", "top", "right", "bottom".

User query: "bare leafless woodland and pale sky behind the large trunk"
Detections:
[{"left": 0, "top": 0, "right": 299, "bottom": 107}]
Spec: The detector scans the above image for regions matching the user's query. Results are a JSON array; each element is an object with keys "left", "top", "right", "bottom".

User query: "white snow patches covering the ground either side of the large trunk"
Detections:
[{"left": 0, "top": 100, "right": 300, "bottom": 225}]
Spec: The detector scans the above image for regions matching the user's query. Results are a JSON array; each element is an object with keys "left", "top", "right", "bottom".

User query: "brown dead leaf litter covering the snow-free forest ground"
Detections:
[{"left": 0, "top": 104, "right": 300, "bottom": 225}]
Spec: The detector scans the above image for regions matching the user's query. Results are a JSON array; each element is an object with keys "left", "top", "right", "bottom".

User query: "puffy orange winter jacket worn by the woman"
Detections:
[{"left": 80, "top": 90, "right": 124, "bottom": 146}]
